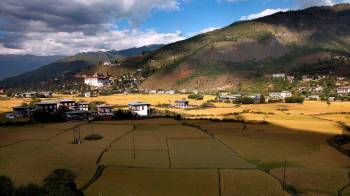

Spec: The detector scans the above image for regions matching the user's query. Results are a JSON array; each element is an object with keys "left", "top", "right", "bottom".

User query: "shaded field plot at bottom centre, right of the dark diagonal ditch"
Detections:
[{"left": 86, "top": 167, "right": 219, "bottom": 196}]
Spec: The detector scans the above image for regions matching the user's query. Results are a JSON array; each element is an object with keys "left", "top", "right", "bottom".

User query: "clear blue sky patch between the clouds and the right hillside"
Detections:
[{"left": 136, "top": 0, "right": 293, "bottom": 35}]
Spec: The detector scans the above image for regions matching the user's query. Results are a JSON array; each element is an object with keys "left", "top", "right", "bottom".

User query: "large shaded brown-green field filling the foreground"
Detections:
[{"left": 0, "top": 117, "right": 350, "bottom": 196}]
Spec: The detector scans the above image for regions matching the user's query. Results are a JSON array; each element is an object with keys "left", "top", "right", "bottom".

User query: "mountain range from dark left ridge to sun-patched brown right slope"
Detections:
[{"left": 0, "top": 4, "right": 350, "bottom": 91}]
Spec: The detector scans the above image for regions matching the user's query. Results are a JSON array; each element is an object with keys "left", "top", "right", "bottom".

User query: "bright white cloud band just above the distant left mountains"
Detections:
[{"left": 0, "top": 29, "right": 185, "bottom": 55}]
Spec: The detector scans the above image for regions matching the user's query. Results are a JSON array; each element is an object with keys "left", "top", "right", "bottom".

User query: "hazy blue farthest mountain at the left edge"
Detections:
[{"left": 0, "top": 54, "right": 63, "bottom": 80}]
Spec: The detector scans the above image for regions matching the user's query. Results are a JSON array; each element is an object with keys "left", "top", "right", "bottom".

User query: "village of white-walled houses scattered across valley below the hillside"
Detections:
[{"left": 6, "top": 68, "right": 350, "bottom": 120}]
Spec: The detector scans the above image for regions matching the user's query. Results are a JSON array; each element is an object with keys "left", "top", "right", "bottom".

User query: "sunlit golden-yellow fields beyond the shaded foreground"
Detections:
[{"left": 0, "top": 94, "right": 350, "bottom": 134}]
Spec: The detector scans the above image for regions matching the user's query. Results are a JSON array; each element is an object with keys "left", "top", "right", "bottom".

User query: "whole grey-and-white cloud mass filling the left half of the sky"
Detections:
[{"left": 0, "top": 0, "right": 183, "bottom": 55}]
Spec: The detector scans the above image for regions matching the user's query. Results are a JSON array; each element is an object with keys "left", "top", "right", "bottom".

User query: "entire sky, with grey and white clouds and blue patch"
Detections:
[{"left": 0, "top": 0, "right": 350, "bottom": 55}]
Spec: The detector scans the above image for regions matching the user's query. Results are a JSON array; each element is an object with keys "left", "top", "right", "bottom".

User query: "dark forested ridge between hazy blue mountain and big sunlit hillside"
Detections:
[{"left": 0, "top": 45, "right": 162, "bottom": 88}]
